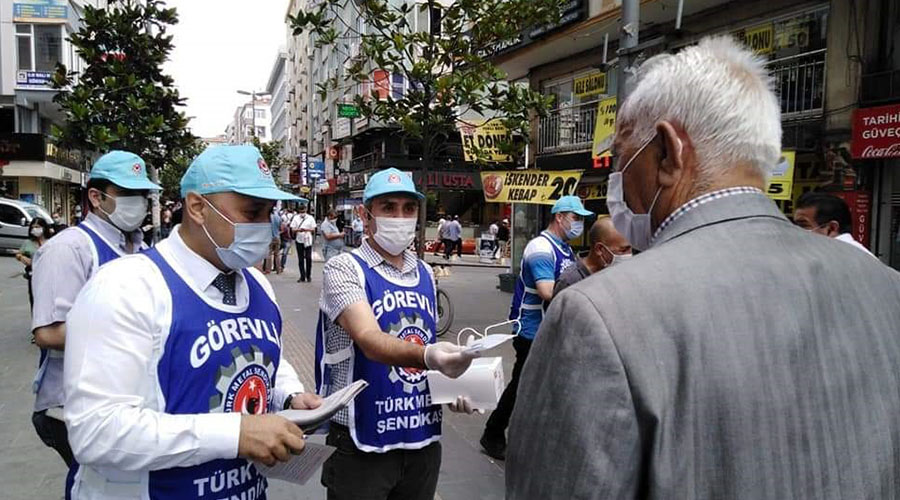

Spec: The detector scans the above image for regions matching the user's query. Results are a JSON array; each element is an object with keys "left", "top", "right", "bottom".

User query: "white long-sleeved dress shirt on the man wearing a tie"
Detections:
[{"left": 64, "top": 226, "right": 303, "bottom": 498}]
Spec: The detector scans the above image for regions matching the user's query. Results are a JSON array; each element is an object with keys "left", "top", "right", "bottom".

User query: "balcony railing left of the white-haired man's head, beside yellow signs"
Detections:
[{"left": 538, "top": 101, "right": 597, "bottom": 154}]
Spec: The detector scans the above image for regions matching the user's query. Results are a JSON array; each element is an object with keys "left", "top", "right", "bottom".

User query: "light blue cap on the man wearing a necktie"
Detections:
[{"left": 181, "top": 145, "right": 306, "bottom": 201}]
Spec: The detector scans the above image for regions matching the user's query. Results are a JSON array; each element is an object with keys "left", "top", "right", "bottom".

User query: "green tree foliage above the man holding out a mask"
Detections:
[{"left": 289, "top": 0, "right": 567, "bottom": 166}]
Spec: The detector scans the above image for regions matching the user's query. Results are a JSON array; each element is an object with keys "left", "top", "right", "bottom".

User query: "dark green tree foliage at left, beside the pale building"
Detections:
[{"left": 53, "top": 0, "right": 196, "bottom": 175}]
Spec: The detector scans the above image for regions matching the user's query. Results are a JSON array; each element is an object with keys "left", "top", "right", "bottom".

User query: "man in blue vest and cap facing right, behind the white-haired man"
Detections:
[{"left": 481, "top": 196, "right": 593, "bottom": 460}]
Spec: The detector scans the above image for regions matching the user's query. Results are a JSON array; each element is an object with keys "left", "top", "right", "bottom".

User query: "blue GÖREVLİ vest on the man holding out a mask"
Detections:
[{"left": 316, "top": 253, "right": 442, "bottom": 453}]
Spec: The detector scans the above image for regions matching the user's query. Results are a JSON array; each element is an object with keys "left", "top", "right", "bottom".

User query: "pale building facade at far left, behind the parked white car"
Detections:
[{"left": 0, "top": 0, "right": 106, "bottom": 220}]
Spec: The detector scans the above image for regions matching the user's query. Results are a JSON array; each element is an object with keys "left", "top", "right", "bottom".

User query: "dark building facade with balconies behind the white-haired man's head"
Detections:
[{"left": 493, "top": 0, "right": 900, "bottom": 272}]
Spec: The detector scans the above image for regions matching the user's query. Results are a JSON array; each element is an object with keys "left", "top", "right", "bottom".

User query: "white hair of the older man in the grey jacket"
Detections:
[{"left": 619, "top": 36, "right": 781, "bottom": 182}]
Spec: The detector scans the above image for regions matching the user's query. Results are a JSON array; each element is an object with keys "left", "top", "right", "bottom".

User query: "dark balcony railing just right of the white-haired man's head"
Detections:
[{"left": 767, "top": 49, "right": 826, "bottom": 121}]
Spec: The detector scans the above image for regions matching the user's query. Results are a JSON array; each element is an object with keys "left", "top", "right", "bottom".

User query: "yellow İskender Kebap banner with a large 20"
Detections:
[{"left": 481, "top": 170, "right": 581, "bottom": 205}]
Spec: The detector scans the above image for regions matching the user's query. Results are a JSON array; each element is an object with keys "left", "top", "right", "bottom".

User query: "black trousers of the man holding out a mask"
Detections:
[{"left": 322, "top": 423, "right": 441, "bottom": 500}]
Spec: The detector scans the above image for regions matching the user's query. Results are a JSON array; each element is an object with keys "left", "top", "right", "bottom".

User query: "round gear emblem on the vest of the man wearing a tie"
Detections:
[{"left": 209, "top": 346, "right": 275, "bottom": 415}]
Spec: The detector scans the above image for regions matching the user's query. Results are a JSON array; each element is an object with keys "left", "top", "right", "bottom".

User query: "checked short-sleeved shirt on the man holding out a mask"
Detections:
[{"left": 319, "top": 238, "right": 436, "bottom": 425}]
